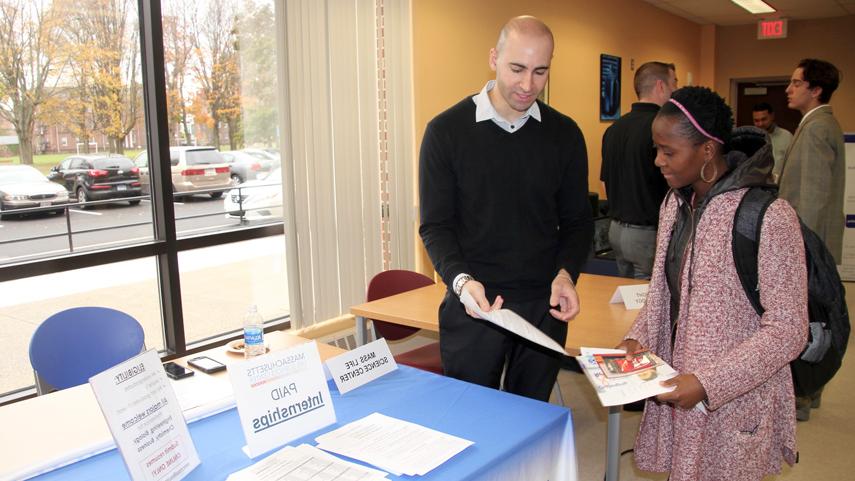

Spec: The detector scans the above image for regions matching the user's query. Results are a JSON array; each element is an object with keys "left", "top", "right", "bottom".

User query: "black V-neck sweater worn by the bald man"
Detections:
[{"left": 419, "top": 97, "right": 593, "bottom": 302}]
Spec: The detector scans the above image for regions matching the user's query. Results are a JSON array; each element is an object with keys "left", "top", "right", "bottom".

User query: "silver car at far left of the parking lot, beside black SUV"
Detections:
[{"left": 0, "top": 165, "right": 68, "bottom": 219}]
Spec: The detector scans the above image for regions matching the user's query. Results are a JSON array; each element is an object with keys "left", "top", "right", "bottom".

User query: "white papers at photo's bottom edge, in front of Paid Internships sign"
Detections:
[{"left": 226, "top": 444, "right": 387, "bottom": 481}]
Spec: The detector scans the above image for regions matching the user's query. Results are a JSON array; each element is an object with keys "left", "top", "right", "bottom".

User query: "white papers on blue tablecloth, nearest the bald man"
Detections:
[{"left": 315, "top": 413, "right": 474, "bottom": 476}]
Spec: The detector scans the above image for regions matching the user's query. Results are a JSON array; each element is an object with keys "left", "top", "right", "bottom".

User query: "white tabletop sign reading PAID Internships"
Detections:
[{"left": 229, "top": 341, "right": 335, "bottom": 458}]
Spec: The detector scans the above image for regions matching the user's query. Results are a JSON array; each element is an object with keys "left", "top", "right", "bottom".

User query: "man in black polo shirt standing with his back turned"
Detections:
[{"left": 600, "top": 62, "right": 677, "bottom": 279}]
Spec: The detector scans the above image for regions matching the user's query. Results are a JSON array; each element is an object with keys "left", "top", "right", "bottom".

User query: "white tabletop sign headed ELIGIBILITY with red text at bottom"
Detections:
[{"left": 89, "top": 349, "right": 199, "bottom": 481}]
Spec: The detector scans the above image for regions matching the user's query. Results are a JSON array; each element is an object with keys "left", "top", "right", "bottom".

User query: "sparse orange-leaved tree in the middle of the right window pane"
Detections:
[{"left": 189, "top": 0, "right": 242, "bottom": 149}]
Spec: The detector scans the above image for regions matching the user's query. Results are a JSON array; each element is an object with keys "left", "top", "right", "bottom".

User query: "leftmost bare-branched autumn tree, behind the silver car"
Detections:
[{"left": 0, "top": 0, "right": 63, "bottom": 165}]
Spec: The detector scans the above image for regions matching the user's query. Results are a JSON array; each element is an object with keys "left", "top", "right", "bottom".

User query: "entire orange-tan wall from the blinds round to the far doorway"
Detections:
[{"left": 412, "top": 0, "right": 855, "bottom": 273}]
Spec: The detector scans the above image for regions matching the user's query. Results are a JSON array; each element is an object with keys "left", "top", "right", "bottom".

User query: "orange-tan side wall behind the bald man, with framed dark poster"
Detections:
[{"left": 413, "top": 0, "right": 711, "bottom": 199}]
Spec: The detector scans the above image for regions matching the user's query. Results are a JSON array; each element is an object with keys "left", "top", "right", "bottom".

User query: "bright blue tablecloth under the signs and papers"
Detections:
[{"left": 33, "top": 366, "right": 577, "bottom": 481}]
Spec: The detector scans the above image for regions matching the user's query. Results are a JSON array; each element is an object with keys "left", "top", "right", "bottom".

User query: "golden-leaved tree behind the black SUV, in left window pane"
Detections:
[{"left": 64, "top": 0, "right": 142, "bottom": 153}]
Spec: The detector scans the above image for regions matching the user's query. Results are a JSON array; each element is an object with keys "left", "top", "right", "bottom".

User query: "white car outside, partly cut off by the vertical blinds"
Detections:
[{"left": 223, "top": 168, "right": 283, "bottom": 221}]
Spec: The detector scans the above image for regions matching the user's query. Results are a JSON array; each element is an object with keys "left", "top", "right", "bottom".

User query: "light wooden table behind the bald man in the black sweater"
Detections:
[{"left": 350, "top": 274, "right": 646, "bottom": 481}]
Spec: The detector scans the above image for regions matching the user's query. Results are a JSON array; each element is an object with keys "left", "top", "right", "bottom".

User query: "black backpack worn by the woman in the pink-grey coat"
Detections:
[{"left": 732, "top": 187, "right": 850, "bottom": 396}]
